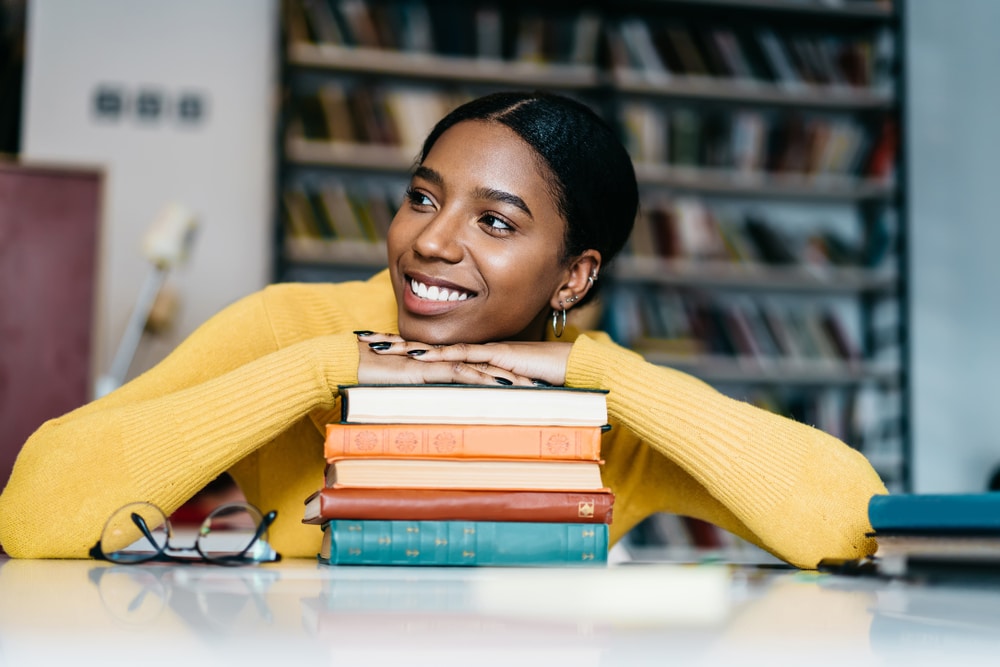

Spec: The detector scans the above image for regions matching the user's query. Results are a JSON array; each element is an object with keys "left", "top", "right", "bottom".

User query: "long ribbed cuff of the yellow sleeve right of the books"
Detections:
[{"left": 566, "top": 336, "right": 808, "bottom": 521}]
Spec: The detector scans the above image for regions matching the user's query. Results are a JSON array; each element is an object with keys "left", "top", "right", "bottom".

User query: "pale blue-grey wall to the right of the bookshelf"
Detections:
[{"left": 906, "top": 0, "right": 1000, "bottom": 492}]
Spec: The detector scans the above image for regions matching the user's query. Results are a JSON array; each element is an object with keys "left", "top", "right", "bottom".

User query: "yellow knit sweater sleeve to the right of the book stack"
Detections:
[{"left": 567, "top": 335, "right": 886, "bottom": 568}]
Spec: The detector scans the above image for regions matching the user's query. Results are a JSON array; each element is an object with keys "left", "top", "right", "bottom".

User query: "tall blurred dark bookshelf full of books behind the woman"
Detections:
[{"left": 274, "top": 0, "right": 910, "bottom": 512}]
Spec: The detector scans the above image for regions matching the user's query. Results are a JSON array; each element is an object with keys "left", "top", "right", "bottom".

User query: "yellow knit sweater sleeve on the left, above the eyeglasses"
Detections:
[{"left": 0, "top": 291, "right": 358, "bottom": 558}]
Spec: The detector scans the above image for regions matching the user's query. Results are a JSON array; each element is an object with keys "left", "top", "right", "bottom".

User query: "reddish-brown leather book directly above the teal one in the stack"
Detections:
[{"left": 302, "top": 487, "right": 615, "bottom": 525}]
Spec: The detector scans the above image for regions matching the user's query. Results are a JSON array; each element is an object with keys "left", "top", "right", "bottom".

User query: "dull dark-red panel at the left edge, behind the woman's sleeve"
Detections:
[{"left": 0, "top": 161, "right": 103, "bottom": 487}]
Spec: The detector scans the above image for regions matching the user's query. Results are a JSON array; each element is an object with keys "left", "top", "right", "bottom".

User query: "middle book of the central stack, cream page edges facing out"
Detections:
[{"left": 326, "top": 457, "right": 604, "bottom": 491}]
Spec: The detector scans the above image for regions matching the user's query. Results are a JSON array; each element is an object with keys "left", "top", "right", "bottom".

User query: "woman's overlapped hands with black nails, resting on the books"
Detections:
[{"left": 358, "top": 333, "right": 572, "bottom": 386}]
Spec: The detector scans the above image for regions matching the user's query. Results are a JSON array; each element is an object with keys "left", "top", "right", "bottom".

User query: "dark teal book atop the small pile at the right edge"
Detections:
[{"left": 868, "top": 492, "right": 1000, "bottom": 535}]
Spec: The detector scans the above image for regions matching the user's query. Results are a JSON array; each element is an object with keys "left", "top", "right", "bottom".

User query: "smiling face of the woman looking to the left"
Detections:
[{"left": 388, "top": 121, "right": 568, "bottom": 344}]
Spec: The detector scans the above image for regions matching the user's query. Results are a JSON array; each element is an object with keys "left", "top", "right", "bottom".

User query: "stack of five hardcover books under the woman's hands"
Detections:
[{"left": 303, "top": 385, "right": 614, "bottom": 566}]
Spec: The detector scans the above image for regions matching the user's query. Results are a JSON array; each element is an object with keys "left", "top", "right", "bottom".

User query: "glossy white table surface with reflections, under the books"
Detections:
[{"left": 0, "top": 558, "right": 1000, "bottom": 667}]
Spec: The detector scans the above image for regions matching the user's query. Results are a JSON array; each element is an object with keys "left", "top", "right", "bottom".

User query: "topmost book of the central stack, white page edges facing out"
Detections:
[{"left": 339, "top": 384, "right": 608, "bottom": 427}]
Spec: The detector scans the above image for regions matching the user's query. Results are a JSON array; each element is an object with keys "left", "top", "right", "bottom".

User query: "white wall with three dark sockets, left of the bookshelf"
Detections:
[{"left": 22, "top": 0, "right": 277, "bottom": 392}]
